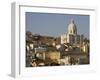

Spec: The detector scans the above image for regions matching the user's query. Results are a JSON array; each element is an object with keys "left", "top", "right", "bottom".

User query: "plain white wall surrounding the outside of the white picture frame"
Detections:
[{"left": 0, "top": 0, "right": 100, "bottom": 80}]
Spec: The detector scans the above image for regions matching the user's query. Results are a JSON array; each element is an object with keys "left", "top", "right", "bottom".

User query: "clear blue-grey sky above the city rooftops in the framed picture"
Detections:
[{"left": 26, "top": 12, "right": 89, "bottom": 38}]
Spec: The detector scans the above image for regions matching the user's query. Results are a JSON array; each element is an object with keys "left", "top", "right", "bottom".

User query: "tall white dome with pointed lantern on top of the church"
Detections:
[{"left": 68, "top": 20, "right": 77, "bottom": 35}]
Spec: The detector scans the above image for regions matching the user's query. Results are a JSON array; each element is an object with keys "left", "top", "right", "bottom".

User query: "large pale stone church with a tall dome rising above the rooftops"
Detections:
[{"left": 61, "top": 20, "right": 83, "bottom": 45}]
